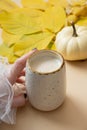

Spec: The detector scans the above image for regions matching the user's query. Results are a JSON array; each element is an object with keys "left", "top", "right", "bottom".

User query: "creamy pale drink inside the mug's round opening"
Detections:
[{"left": 30, "top": 50, "right": 63, "bottom": 73}]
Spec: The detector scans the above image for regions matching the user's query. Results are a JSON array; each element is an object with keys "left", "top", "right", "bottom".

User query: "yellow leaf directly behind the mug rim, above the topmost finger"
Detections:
[{"left": 14, "top": 31, "right": 55, "bottom": 56}]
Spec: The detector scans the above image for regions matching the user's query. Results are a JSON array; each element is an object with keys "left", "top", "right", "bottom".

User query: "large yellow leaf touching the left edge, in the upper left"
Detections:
[{"left": 0, "top": 10, "right": 42, "bottom": 35}]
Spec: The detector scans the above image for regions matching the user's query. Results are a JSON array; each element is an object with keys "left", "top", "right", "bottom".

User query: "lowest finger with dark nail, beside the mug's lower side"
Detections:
[{"left": 12, "top": 94, "right": 28, "bottom": 108}]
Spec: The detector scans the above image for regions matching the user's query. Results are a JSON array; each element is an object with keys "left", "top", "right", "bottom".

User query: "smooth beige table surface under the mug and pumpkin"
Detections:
[{"left": 0, "top": 61, "right": 87, "bottom": 130}]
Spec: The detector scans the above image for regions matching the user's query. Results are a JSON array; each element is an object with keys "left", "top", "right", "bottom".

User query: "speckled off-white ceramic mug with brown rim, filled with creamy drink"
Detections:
[{"left": 26, "top": 50, "right": 66, "bottom": 111}]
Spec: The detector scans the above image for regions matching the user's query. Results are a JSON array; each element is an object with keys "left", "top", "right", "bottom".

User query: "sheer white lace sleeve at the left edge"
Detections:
[{"left": 0, "top": 56, "right": 16, "bottom": 124}]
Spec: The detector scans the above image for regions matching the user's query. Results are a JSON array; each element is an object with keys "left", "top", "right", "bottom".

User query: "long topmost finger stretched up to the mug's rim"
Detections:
[{"left": 8, "top": 49, "right": 37, "bottom": 84}]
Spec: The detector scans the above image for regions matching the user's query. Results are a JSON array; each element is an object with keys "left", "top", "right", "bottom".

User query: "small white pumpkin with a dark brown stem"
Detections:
[{"left": 55, "top": 24, "right": 87, "bottom": 60}]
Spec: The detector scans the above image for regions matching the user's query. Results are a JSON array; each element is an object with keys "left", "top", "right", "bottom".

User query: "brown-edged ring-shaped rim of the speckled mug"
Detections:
[{"left": 27, "top": 49, "right": 65, "bottom": 75}]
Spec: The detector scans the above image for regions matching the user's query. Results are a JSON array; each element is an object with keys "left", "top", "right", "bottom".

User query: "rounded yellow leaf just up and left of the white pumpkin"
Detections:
[{"left": 41, "top": 6, "right": 66, "bottom": 33}]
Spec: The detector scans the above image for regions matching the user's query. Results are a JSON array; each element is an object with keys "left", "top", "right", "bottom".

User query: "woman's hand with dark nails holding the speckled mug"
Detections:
[{"left": 7, "top": 49, "right": 37, "bottom": 107}]
